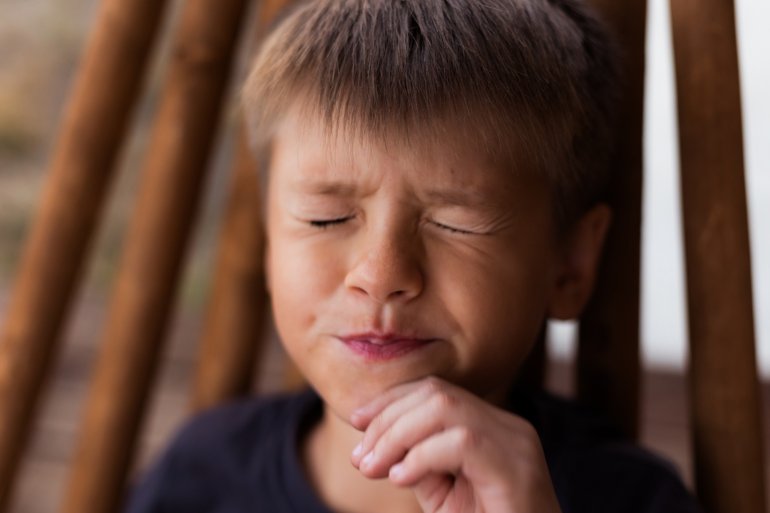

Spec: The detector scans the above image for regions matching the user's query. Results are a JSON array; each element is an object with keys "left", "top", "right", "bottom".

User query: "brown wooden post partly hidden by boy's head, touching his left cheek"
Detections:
[{"left": 192, "top": 0, "right": 291, "bottom": 410}]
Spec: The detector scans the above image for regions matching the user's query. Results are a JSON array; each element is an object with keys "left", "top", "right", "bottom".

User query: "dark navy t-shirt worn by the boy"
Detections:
[{"left": 126, "top": 390, "right": 700, "bottom": 513}]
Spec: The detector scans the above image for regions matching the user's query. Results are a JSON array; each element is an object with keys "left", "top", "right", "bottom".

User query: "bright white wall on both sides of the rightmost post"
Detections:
[{"left": 641, "top": 0, "right": 770, "bottom": 377}]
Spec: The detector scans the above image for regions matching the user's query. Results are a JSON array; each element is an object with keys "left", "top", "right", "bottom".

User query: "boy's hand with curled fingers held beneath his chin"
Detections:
[{"left": 351, "top": 378, "right": 560, "bottom": 513}]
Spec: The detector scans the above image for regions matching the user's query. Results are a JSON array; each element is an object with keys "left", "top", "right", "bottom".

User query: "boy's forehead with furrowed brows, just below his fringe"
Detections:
[{"left": 269, "top": 103, "right": 545, "bottom": 200}]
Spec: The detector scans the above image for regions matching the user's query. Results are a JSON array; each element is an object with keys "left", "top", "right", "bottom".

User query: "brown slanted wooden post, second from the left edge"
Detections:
[{"left": 62, "top": 0, "right": 252, "bottom": 513}]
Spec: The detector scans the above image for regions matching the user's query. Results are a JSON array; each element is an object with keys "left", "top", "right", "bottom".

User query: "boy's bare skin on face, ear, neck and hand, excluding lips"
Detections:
[{"left": 266, "top": 106, "right": 609, "bottom": 513}]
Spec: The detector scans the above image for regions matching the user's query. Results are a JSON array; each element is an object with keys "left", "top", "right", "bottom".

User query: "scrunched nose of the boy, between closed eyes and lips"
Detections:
[{"left": 345, "top": 225, "right": 424, "bottom": 303}]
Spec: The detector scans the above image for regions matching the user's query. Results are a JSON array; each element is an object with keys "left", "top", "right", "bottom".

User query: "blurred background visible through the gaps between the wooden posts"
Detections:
[{"left": 0, "top": 0, "right": 770, "bottom": 513}]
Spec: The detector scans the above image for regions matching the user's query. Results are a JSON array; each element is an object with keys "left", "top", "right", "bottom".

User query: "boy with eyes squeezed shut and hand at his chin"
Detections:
[{"left": 129, "top": 0, "right": 697, "bottom": 513}]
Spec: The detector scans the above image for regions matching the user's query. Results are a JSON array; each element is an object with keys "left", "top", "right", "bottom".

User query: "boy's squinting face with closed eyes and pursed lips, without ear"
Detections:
[{"left": 267, "top": 111, "right": 557, "bottom": 419}]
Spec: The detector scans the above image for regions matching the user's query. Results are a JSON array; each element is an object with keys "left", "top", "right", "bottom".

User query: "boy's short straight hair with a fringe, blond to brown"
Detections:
[{"left": 243, "top": 0, "right": 617, "bottom": 225}]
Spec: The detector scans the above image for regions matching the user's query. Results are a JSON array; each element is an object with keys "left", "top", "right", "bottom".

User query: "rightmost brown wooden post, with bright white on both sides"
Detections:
[{"left": 671, "top": 0, "right": 766, "bottom": 513}]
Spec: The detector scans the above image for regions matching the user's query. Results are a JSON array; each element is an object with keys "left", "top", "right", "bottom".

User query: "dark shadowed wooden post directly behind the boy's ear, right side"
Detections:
[{"left": 577, "top": 0, "right": 647, "bottom": 437}]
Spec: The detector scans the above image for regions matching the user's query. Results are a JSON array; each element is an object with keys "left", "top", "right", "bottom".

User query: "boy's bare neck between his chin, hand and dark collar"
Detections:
[{"left": 301, "top": 406, "right": 422, "bottom": 513}]
